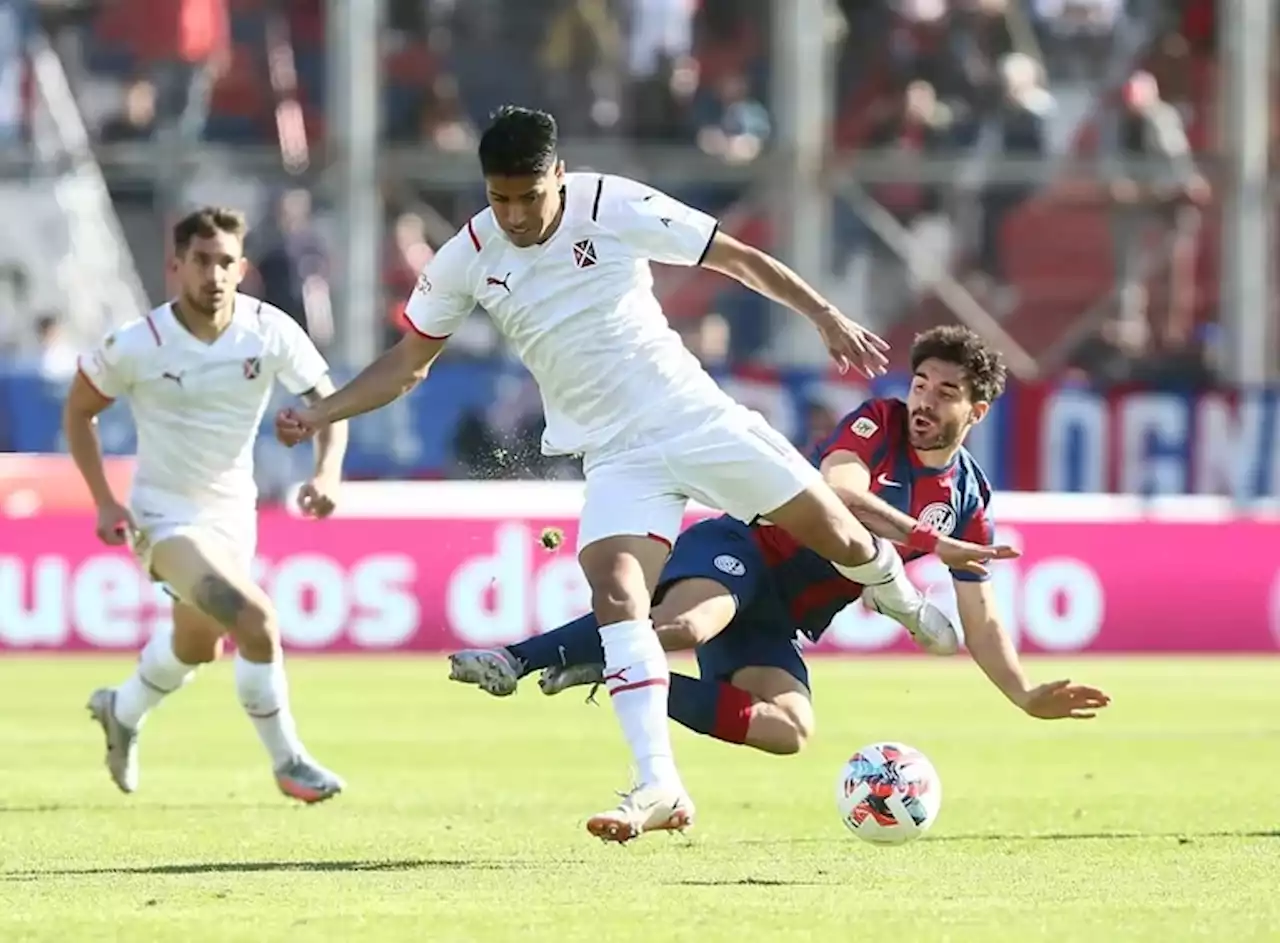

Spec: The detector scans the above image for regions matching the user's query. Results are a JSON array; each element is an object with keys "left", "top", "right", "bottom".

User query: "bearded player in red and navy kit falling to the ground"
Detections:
[{"left": 451, "top": 326, "right": 1110, "bottom": 754}]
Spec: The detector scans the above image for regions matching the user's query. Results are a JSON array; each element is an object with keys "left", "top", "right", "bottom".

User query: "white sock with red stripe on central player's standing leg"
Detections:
[{"left": 600, "top": 619, "right": 680, "bottom": 786}]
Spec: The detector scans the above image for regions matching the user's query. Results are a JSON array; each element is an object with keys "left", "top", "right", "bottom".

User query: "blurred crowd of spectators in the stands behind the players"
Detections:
[{"left": 0, "top": 0, "right": 1280, "bottom": 478}]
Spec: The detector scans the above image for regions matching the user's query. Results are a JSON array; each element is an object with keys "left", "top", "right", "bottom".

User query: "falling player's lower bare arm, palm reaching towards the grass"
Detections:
[{"left": 954, "top": 580, "right": 1111, "bottom": 720}]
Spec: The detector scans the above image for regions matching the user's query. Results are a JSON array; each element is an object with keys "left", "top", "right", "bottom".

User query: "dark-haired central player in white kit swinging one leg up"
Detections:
[{"left": 276, "top": 106, "right": 955, "bottom": 842}]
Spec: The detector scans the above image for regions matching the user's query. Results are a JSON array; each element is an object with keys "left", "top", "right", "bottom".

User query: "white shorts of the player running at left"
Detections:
[{"left": 129, "top": 491, "right": 257, "bottom": 582}]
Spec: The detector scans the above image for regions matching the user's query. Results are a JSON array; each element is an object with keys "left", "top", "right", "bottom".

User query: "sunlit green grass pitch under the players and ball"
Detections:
[{"left": 0, "top": 656, "right": 1280, "bottom": 943}]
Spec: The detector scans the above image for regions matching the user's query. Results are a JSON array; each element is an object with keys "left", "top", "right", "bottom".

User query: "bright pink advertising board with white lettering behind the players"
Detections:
[{"left": 0, "top": 505, "right": 1280, "bottom": 654}]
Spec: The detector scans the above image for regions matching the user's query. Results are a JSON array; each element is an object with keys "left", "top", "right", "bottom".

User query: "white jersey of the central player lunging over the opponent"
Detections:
[{"left": 406, "top": 174, "right": 735, "bottom": 454}]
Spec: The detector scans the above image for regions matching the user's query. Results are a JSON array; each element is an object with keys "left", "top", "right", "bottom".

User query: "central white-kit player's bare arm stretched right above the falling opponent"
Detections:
[{"left": 701, "top": 230, "right": 888, "bottom": 377}]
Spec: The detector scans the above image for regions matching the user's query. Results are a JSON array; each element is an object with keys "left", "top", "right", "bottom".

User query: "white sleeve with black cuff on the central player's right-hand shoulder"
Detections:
[{"left": 593, "top": 174, "right": 719, "bottom": 265}]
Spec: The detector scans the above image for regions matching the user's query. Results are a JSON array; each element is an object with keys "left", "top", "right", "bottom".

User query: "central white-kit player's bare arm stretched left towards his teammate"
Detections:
[{"left": 275, "top": 333, "right": 445, "bottom": 445}]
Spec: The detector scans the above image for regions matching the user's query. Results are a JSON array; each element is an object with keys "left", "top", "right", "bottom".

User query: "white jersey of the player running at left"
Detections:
[{"left": 79, "top": 294, "right": 329, "bottom": 508}]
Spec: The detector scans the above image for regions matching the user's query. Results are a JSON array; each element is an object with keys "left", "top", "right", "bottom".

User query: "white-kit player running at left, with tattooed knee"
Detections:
[{"left": 64, "top": 209, "right": 347, "bottom": 802}]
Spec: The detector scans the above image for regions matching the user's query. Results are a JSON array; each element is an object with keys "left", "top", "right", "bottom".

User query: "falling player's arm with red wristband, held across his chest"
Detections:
[{"left": 822, "top": 450, "right": 1019, "bottom": 576}]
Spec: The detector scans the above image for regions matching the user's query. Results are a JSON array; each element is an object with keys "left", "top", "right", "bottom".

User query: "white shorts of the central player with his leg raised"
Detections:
[{"left": 577, "top": 406, "right": 822, "bottom": 551}]
